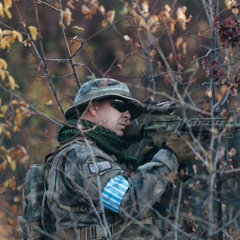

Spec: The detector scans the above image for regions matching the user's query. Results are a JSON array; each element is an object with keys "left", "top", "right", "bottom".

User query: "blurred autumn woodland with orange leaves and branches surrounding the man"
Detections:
[{"left": 0, "top": 0, "right": 240, "bottom": 240}]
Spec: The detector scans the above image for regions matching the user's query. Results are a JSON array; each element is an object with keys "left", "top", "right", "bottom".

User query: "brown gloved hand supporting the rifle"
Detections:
[{"left": 166, "top": 131, "right": 195, "bottom": 163}]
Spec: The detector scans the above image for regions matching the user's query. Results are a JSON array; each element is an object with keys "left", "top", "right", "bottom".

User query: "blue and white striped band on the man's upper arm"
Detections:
[{"left": 102, "top": 175, "right": 129, "bottom": 213}]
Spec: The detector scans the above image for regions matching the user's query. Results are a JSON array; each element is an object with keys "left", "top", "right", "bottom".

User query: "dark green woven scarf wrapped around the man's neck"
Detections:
[{"left": 57, "top": 119, "right": 138, "bottom": 165}]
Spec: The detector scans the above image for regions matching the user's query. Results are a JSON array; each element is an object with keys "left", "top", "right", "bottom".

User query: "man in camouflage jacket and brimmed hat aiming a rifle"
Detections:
[{"left": 36, "top": 78, "right": 193, "bottom": 240}]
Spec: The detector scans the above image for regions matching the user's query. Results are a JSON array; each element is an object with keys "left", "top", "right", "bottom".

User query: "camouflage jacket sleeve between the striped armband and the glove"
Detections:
[{"left": 119, "top": 149, "right": 179, "bottom": 217}]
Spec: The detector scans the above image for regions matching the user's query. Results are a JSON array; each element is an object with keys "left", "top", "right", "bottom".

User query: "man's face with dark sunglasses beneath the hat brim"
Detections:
[{"left": 96, "top": 99, "right": 131, "bottom": 137}]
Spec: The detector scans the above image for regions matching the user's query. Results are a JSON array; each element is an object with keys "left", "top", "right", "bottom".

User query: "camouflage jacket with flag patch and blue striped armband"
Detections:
[{"left": 46, "top": 140, "right": 179, "bottom": 235}]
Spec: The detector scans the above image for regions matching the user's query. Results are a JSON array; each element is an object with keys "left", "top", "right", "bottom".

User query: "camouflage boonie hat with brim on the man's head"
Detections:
[{"left": 64, "top": 78, "right": 143, "bottom": 120}]
